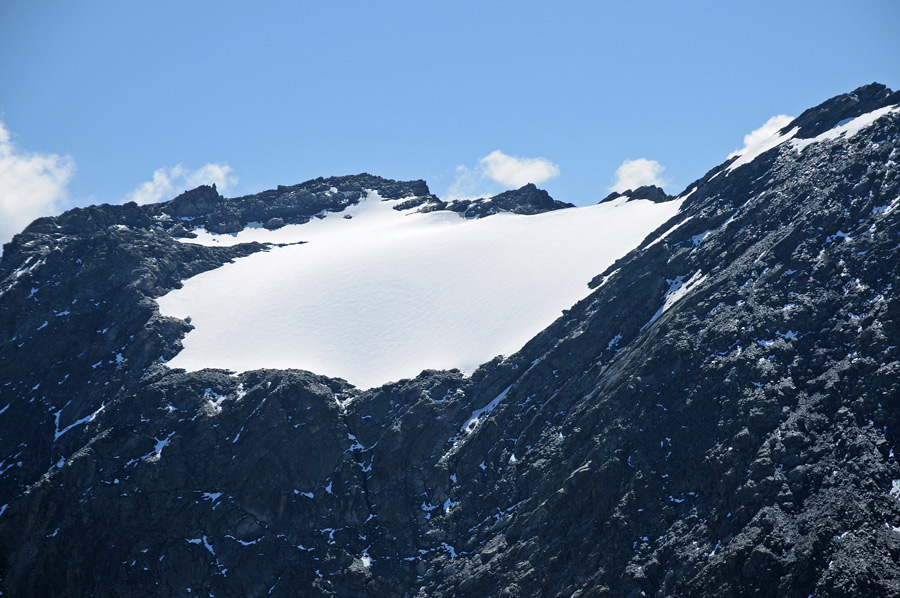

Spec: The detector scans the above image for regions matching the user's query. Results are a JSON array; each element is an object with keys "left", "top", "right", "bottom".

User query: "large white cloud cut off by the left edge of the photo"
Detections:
[{"left": 0, "top": 121, "right": 75, "bottom": 252}]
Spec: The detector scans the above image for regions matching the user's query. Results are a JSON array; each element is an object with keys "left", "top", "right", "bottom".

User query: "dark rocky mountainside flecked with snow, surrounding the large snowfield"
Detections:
[{"left": 0, "top": 86, "right": 900, "bottom": 597}]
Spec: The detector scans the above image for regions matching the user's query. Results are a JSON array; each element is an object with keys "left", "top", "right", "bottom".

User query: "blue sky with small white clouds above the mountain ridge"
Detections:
[{"left": 0, "top": 0, "right": 900, "bottom": 242}]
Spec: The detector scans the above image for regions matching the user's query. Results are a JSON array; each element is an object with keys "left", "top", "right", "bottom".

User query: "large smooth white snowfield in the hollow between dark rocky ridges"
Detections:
[{"left": 159, "top": 194, "right": 681, "bottom": 388}]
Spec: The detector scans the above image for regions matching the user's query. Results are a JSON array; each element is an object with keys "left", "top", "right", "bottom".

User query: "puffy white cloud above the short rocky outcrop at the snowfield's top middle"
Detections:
[{"left": 446, "top": 150, "right": 559, "bottom": 200}]
